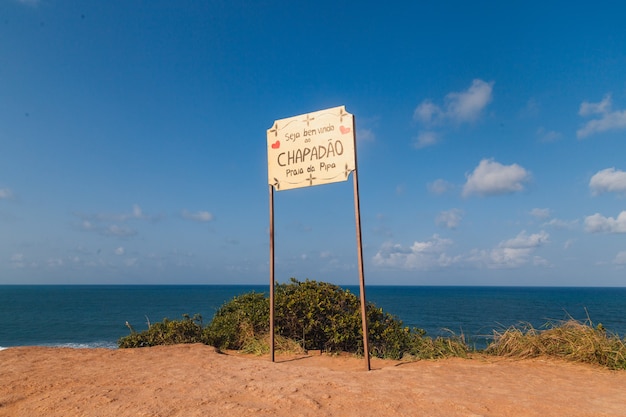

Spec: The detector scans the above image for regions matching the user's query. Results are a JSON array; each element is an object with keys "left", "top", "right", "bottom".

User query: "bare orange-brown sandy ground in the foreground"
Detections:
[{"left": 0, "top": 345, "right": 626, "bottom": 417}]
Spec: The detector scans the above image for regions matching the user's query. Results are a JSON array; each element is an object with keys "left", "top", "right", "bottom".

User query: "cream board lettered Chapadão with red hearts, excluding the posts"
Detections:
[{"left": 267, "top": 106, "right": 356, "bottom": 191}]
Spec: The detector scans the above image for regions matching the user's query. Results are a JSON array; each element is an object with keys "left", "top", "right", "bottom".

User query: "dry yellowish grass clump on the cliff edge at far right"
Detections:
[{"left": 486, "top": 320, "right": 626, "bottom": 369}]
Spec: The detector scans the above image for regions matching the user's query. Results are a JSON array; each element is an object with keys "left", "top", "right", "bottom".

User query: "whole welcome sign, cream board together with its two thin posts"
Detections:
[{"left": 267, "top": 106, "right": 370, "bottom": 370}]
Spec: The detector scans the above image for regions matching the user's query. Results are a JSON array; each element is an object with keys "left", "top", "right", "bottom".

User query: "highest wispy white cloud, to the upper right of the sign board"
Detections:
[{"left": 413, "top": 79, "right": 494, "bottom": 125}]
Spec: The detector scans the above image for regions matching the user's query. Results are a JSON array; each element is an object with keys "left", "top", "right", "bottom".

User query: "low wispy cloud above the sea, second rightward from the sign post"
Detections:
[{"left": 469, "top": 230, "right": 550, "bottom": 269}]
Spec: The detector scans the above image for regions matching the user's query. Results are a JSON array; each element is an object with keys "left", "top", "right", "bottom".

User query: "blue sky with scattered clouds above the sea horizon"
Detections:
[{"left": 0, "top": 0, "right": 626, "bottom": 286}]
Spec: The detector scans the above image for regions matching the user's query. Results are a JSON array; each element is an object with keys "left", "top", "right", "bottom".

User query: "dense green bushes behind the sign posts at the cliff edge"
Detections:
[{"left": 118, "top": 278, "right": 467, "bottom": 359}]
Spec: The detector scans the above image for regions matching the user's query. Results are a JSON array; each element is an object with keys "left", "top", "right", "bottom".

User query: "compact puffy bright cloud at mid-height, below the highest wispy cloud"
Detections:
[{"left": 463, "top": 159, "right": 530, "bottom": 196}]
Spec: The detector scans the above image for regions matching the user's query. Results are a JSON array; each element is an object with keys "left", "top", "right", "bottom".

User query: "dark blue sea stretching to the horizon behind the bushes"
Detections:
[{"left": 0, "top": 285, "right": 626, "bottom": 349}]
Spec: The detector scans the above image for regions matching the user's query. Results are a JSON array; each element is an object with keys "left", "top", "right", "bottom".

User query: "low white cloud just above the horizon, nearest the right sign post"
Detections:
[{"left": 372, "top": 235, "right": 457, "bottom": 270}]
